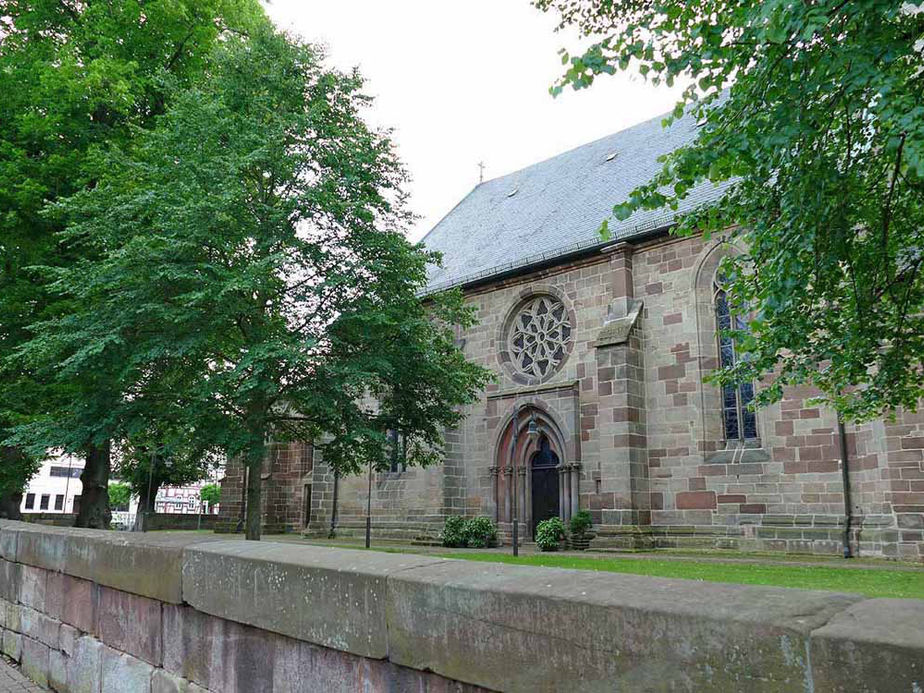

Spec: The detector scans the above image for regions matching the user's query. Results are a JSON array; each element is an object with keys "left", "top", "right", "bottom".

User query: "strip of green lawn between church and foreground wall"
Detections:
[{"left": 441, "top": 553, "right": 924, "bottom": 599}]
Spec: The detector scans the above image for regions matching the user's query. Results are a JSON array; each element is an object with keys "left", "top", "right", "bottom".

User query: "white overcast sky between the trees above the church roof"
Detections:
[{"left": 266, "top": 0, "right": 680, "bottom": 240}]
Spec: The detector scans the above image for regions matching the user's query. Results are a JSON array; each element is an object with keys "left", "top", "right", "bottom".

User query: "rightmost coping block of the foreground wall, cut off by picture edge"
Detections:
[{"left": 811, "top": 599, "right": 924, "bottom": 693}]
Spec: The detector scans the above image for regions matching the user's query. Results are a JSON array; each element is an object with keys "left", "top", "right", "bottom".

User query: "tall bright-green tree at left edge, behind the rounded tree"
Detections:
[{"left": 0, "top": 0, "right": 267, "bottom": 527}]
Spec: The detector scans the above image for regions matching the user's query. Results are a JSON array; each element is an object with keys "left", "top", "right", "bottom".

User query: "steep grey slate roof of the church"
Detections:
[{"left": 423, "top": 109, "right": 725, "bottom": 293}]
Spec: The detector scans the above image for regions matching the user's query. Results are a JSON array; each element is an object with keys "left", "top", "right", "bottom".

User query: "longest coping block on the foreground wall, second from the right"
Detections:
[{"left": 388, "top": 561, "right": 860, "bottom": 691}]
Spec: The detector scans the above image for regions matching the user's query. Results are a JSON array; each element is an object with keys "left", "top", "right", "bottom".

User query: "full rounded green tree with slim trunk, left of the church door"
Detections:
[{"left": 27, "top": 30, "right": 487, "bottom": 539}]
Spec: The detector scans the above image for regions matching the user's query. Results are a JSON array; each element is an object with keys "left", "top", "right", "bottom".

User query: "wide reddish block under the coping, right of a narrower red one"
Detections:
[{"left": 97, "top": 587, "right": 163, "bottom": 666}]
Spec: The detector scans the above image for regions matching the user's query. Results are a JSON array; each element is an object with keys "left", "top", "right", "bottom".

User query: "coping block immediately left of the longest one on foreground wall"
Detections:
[{"left": 183, "top": 541, "right": 444, "bottom": 658}]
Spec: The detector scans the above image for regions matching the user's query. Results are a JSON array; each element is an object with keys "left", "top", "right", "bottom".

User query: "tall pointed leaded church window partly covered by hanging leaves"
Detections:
[{"left": 712, "top": 272, "right": 757, "bottom": 440}]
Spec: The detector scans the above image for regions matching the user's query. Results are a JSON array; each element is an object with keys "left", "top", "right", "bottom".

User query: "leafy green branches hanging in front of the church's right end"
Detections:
[{"left": 536, "top": 0, "right": 924, "bottom": 420}]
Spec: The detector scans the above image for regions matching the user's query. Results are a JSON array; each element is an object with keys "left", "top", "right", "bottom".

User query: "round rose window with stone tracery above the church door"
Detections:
[{"left": 508, "top": 296, "right": 571, "bottom": 378}]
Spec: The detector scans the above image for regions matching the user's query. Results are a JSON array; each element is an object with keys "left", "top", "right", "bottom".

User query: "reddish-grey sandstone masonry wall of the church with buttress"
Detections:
[{"left": 290, "top": 236, "right": 924, "bottom": 560}]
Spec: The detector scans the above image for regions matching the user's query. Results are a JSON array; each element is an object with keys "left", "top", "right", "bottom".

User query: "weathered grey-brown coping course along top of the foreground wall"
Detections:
[{"left": 0, "top": 521, "right": 924, "bottom": 693}]
